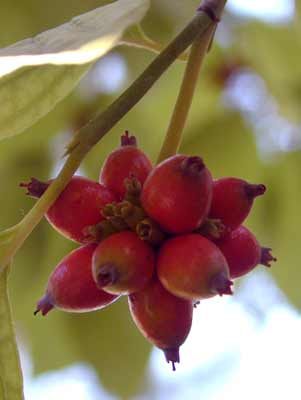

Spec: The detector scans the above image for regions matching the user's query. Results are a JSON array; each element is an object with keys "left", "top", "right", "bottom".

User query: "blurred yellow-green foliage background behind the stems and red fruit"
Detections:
[{"left": 0, "top": 0, "right": 301, "bottom": 398}]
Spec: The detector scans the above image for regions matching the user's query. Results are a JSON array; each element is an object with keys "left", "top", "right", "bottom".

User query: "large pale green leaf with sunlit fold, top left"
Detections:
[{"left": 0, "top": 0, "right": 149, "bottom": 138}]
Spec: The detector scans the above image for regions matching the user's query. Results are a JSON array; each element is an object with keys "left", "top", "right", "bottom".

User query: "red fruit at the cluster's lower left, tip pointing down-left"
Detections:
[{"left": 35, "top": 244, "right": 118, "bottom": 315}]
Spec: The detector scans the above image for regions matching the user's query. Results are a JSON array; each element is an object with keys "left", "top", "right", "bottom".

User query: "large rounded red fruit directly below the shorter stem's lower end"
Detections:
[{"left": 141, "top": 155, "right": 212, "bottom": 234}]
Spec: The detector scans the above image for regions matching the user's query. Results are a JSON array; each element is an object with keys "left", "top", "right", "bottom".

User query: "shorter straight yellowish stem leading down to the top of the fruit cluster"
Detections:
[{"left": 157, "top": 0, "right": 226, "bottom": 163}]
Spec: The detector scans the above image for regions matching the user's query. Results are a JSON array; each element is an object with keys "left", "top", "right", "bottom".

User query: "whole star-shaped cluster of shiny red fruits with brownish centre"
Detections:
[{"left": 21, "top": 132, "right": 275, "bottom": 369}]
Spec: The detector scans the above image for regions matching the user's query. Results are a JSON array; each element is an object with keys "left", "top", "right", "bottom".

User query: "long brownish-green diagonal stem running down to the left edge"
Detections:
[{"left": 0, "top": 0, "right": 226, "bottom": 273}]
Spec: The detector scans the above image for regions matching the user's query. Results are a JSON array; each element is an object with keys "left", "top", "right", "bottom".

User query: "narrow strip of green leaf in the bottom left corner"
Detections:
[{"left": 0, "top": 267, "right": 24, "bottom": 400}]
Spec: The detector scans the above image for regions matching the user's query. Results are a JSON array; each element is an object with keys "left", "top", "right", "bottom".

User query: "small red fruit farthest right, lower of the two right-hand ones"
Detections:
[{"left": 216, "top": 226, "right": 276, "bottom": 278}]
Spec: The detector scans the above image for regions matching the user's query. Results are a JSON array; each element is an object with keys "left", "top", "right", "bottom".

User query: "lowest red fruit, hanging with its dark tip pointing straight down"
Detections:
[{"left": 129, "top": 279, "right": 193, "bottom": 370}]
